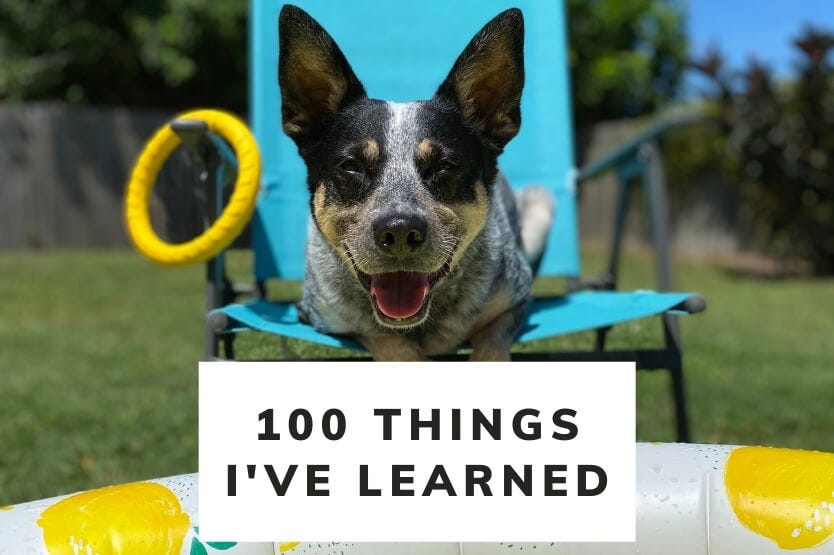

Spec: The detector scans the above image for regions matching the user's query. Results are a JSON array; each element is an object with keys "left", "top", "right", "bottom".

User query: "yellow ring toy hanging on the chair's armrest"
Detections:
[{"left": 125, "top": 110, "right": 261, "bottom": 266}]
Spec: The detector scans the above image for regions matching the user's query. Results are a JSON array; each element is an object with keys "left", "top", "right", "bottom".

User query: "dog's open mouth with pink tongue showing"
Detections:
[{"left": 354, "top": 259, "right": 451, "bottom": 325}]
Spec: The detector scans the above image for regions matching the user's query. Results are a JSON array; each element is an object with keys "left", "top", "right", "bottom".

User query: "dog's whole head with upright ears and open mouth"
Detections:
[{"left": 278, "top": 6, "right": 524, "bottom": 328}]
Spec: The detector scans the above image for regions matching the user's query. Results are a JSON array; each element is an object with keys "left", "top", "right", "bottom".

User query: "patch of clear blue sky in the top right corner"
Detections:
[{"left": 688, "top": 0, "right": 834, "bottom": 76}]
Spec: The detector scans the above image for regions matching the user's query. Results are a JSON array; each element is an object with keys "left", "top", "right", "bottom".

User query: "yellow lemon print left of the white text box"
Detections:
[{"left": 38, "top": 482, "right": 190, "bottom": 555}]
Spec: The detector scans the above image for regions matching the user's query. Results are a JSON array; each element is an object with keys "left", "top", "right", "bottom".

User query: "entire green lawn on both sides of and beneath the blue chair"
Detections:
[{"left": 0, "top": 251, "right": 834, "bottom": 505}]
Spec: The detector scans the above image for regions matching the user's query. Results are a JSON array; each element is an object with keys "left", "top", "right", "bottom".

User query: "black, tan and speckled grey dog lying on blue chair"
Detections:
[{"left": 278, "top": 5, "right": 553, "bottom": 361}]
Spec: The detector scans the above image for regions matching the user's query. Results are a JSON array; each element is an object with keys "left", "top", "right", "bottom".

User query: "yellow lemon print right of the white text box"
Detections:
[{"left": 724, "top": 447, "right": 834, "bottom": 549}]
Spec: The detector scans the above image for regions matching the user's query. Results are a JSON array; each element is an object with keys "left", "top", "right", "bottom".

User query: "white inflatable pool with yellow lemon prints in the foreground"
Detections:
[{"left": 0, "top": 443, "right": 834, "bottom": 555}]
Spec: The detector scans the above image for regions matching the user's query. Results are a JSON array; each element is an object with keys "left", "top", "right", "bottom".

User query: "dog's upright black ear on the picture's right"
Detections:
[{"left": 436, "top": 8, "right": 524, "bottom": 148}]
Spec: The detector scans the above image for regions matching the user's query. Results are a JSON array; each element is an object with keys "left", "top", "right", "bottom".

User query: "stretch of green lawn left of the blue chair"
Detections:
[{"left": 0, "top": 251, "right": 203, "bottom": 505}]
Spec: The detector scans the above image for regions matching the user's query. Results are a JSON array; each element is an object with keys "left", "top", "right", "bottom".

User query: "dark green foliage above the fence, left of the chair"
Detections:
[{"left": 0, "top": 0, "right": 247, "bottom": 111}]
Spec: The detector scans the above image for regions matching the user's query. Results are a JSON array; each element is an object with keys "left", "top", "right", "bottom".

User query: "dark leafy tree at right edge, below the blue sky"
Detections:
[{"left": 693, "top": 28, "right": 834, "bottom": 275}]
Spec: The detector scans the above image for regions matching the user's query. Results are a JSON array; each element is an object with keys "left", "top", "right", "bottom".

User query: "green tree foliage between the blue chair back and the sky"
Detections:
[{"left": 567, "top": 0, "right": 687, "bottom": 128}]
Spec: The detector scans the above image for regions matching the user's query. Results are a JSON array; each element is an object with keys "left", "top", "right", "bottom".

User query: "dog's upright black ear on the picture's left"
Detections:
[{"left": 278, "top": 4, "right": 365, "bottom": 143}]
